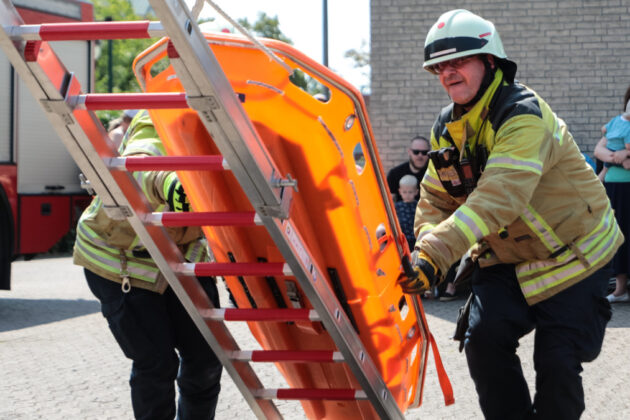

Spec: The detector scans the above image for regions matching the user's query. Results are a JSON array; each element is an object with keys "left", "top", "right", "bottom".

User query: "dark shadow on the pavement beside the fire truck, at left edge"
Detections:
[{"left": 0, "top": 299, "right": 101, "bottom": 332}]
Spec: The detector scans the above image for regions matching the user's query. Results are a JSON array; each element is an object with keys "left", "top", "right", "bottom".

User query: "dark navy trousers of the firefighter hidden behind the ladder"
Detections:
[{"left": 85, "top": 270, "right": 222, "bottom": 420}]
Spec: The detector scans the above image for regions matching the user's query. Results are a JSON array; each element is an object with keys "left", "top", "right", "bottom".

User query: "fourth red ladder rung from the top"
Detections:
[{"left": 144, "top": 211, "right": 262, "bottom": 227}]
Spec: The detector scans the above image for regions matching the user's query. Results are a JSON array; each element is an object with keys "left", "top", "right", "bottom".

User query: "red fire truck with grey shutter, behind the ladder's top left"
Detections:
[{"left": 0, "top": 0, "right": 94, "bottom": 289}]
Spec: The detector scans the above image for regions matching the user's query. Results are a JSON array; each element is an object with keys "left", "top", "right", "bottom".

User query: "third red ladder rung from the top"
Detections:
[{"left": 107, "top": 155, "right": 228, "bottom": 172}]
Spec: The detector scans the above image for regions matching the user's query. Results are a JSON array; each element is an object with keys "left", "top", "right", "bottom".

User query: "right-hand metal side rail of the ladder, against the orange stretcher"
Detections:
[{"left": 150, "top": 0, "right": 404, "bottom": 419}]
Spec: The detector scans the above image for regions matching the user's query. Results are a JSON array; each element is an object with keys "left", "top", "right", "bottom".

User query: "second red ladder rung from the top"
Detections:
[{"left": 79, "top": 92, "right": 189, "bottom": 111}]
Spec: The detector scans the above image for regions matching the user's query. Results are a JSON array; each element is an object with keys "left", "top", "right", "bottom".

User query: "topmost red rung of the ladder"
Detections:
[{"left": 6, "top": 20, "right": 165, "bottom": 41}]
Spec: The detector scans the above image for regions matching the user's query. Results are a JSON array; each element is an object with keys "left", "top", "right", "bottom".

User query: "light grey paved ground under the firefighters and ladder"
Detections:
[{"left": 0, "top": 257, "right": 630, "bottom": 420}]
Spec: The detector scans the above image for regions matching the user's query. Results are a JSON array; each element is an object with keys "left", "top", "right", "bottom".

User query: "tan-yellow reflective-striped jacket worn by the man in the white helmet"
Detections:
[{"left": 414, "top": 70, "right": 623, "bottom": 305}]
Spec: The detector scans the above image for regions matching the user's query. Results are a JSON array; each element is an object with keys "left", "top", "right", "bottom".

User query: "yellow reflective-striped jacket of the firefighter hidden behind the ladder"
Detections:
[{"left": 73, "top": 111, "right": 209, "bottom": 293}]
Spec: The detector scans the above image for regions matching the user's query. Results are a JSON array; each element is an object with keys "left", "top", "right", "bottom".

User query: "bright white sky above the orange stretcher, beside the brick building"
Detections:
[{"left": 181, "top": 0, "right": 370, "bottom": 89}]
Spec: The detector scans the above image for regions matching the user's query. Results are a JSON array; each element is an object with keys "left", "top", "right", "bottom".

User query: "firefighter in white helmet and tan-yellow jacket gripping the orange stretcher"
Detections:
[{"left": 399, "top": 9, "right": 624, "bottom": 419}]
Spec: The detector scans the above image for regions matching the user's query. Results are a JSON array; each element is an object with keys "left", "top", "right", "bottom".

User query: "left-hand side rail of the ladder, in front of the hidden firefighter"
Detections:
[{"left": 0, "top": 0, "right": 282, "bottom": 419}]
